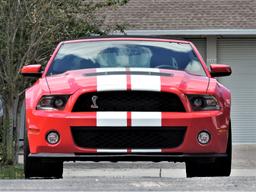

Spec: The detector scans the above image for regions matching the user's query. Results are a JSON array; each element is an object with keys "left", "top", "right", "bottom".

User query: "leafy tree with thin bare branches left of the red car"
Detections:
[{"left": 0, "top": 0, "right": 126, "bottom": 163}]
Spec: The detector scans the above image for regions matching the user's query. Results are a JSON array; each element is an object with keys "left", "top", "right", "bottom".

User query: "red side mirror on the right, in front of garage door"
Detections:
[{"left": 210, "top": 64, "right": 232, "bottom": 77}]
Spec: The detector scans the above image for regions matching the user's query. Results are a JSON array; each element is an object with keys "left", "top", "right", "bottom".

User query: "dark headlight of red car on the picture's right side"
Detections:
[{"left": 188, "top": 95, "right": 220, "bottom": 111}]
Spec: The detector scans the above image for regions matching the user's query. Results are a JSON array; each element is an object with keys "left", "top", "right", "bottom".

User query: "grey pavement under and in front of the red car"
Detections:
[{"left": 0, "top": 144, "right": 256, "bottom": 192}]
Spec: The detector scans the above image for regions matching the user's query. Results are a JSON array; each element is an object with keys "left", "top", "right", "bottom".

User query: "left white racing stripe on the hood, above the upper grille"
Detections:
[{"left": 97, "top": 68, "right": 127, "bottom": 91}]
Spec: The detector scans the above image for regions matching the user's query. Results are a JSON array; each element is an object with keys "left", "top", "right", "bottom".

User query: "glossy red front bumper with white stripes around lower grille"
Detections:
[{"left": 27, "top": 110, "right": 229, "bottom": 156}]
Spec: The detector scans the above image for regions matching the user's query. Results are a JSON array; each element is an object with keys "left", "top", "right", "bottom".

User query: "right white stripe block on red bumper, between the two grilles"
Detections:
[{"left": 131, "top": 112, "right": 162, "bottom": 127}]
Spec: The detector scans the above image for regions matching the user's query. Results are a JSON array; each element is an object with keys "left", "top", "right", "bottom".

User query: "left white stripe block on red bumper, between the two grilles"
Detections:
[{"left": 96, "top": 112, "right": 127, "bottom": 127}]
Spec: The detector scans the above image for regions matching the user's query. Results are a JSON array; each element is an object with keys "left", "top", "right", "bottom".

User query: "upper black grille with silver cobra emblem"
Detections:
[{"left": 72, "top": 91, "right": 185, "bottom": 112}]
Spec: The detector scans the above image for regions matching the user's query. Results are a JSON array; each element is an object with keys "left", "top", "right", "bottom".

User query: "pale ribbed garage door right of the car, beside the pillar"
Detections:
[{"left": 217, "top": 39, "right": 256, "bottom": 143}]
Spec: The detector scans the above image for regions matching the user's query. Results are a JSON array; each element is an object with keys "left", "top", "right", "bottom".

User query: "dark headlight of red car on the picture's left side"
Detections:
[{"left": 36, "top": 95, "right": 69, "bottom": 110}]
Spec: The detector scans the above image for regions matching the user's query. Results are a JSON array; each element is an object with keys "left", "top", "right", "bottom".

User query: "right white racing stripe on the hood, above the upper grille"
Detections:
[{"left": 130, "top": 68, "right": 161, "bottom": 91}]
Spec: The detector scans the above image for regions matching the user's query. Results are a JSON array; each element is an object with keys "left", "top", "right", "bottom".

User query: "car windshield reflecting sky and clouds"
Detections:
[{"left": 47, "top": 41, "right": 205, "bottom": 76}]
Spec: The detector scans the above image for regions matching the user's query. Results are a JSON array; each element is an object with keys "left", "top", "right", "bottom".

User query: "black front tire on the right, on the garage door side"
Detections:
[{"left": 186, "top": 125, "right": 232, "bottom": 177}]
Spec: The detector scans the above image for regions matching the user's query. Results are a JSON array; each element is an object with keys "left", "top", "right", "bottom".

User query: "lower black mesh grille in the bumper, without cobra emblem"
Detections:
[{"left": 71, "top": 127, "right": 186, "bottom": 149}]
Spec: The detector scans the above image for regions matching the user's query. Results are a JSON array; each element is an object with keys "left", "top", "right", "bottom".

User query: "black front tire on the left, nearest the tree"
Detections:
[{"left": 23, "top": 109, "right": 63, "bottom": 179}]
